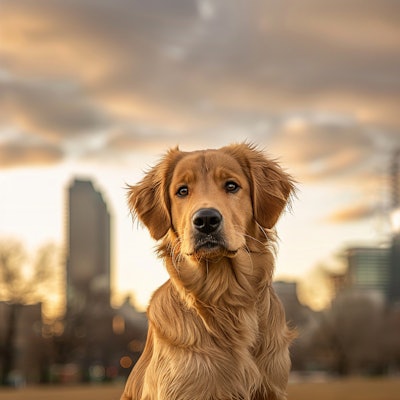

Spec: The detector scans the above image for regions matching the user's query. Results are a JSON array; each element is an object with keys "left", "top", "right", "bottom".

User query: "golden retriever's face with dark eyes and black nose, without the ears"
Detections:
[{"left": 168, "top": 150, "right": 253, "bottom": 258}]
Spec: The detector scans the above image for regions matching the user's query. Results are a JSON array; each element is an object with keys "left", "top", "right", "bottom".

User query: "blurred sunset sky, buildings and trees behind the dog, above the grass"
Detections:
[{"left": 0, "top": 0, "right": 400, "bottom": 386}]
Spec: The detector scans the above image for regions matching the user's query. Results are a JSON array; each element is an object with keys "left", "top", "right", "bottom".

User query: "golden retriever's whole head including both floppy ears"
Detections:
[{"left": 129, "top": 144, "right": 294, "bottom": 259}]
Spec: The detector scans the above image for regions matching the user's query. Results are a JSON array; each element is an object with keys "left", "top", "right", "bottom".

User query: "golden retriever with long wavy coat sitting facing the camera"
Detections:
[{"left": 121, "top": 143, "right": 295, "bottom": 400}]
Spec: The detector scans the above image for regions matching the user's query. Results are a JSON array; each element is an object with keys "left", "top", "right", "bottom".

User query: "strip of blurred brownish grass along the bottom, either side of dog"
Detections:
[{"left": 0, "top": 378, "right": 400, "bottom": 400}]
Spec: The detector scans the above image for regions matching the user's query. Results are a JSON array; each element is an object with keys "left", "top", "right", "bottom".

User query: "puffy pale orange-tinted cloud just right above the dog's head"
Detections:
[{"left": 264, "top": 112, "right": 382, "bottom": 181}]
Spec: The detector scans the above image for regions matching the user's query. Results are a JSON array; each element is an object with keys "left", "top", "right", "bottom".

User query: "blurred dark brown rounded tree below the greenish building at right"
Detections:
[{"left": 313, "top": 290, "right": 386, "bottom": 375}]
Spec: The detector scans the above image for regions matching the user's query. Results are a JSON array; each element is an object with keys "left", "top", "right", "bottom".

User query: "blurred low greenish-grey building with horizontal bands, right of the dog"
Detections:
[{"left": 346, "top": 247, "right": 391, "bottom": 299}]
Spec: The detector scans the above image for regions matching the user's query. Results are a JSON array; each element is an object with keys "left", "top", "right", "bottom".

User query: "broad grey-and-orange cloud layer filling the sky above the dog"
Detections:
[{"left": 0, "top": 0, "right": 400, "bottom": 169}]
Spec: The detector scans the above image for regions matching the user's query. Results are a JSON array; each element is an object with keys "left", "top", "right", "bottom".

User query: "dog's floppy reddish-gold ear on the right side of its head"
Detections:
[{"left": 227, "top": 143, "right": 295, "bottom": 229}]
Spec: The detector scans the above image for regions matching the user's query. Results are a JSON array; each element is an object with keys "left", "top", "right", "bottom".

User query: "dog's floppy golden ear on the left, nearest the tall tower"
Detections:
[{"left": 128, "top": 148, "right": 181, "bottom": 240}]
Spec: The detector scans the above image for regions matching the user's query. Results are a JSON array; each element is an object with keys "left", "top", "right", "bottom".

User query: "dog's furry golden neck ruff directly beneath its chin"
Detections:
[{"left": 158, "top": 227, "right": 275, "bottom": 309}]
